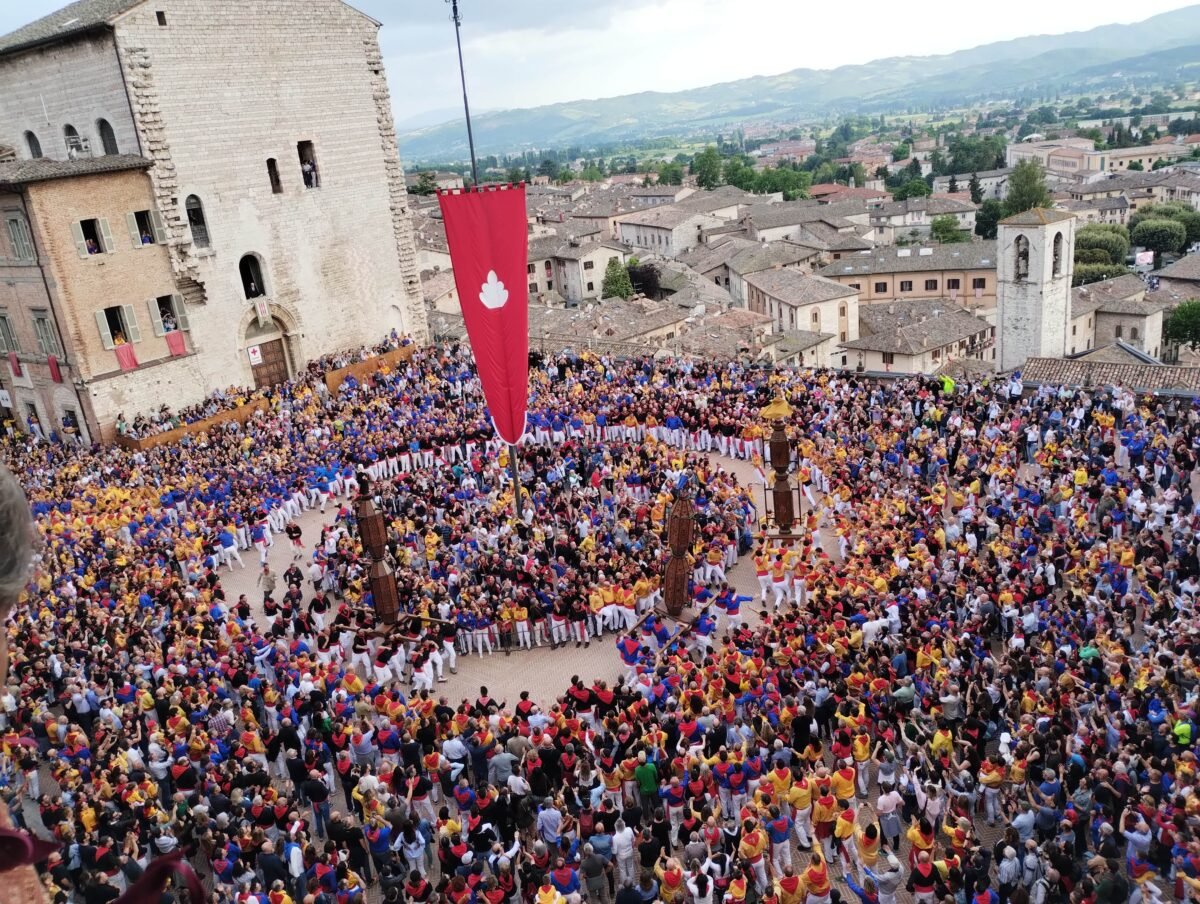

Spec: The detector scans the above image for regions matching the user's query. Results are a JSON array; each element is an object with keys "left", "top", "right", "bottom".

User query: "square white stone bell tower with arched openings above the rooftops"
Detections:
[{"left": 996, "top": 208, "right": 1075, "bottom": 372}]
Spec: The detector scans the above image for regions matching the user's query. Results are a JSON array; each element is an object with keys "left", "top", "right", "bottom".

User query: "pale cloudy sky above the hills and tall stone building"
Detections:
[{"left": 0, "top": 0, "right": 1188, "bottom": 128}]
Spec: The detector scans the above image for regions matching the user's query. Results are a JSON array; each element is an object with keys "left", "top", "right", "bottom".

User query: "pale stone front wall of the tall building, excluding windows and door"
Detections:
[{"left": 116, "top": 0, "right": 425, "bottom": 383}]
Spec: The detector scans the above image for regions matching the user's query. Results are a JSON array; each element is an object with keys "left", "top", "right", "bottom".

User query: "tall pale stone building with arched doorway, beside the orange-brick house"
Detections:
[{"left": 0, "top": 0, "right": 426, "bottom": 436}]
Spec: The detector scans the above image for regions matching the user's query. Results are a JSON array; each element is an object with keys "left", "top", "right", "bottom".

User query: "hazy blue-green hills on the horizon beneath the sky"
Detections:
[{"left": 400, "top": 6, "right": 1200, "bottom": 161}]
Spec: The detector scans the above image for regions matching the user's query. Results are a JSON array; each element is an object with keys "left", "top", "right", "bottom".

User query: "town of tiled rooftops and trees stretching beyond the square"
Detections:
[{"left": 407, "top": 90, "right": 1200, "bottom": 382}]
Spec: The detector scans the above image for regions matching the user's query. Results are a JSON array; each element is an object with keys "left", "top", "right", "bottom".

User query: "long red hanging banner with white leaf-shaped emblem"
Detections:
[{"left": 438, "top": 184, "right": 529, "bottom": 443}]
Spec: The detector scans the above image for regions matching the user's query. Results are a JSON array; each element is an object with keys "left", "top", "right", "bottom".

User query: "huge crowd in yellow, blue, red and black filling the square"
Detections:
[{"left": 0, "top": 333, "right": 1200, "bottom": 904}]
